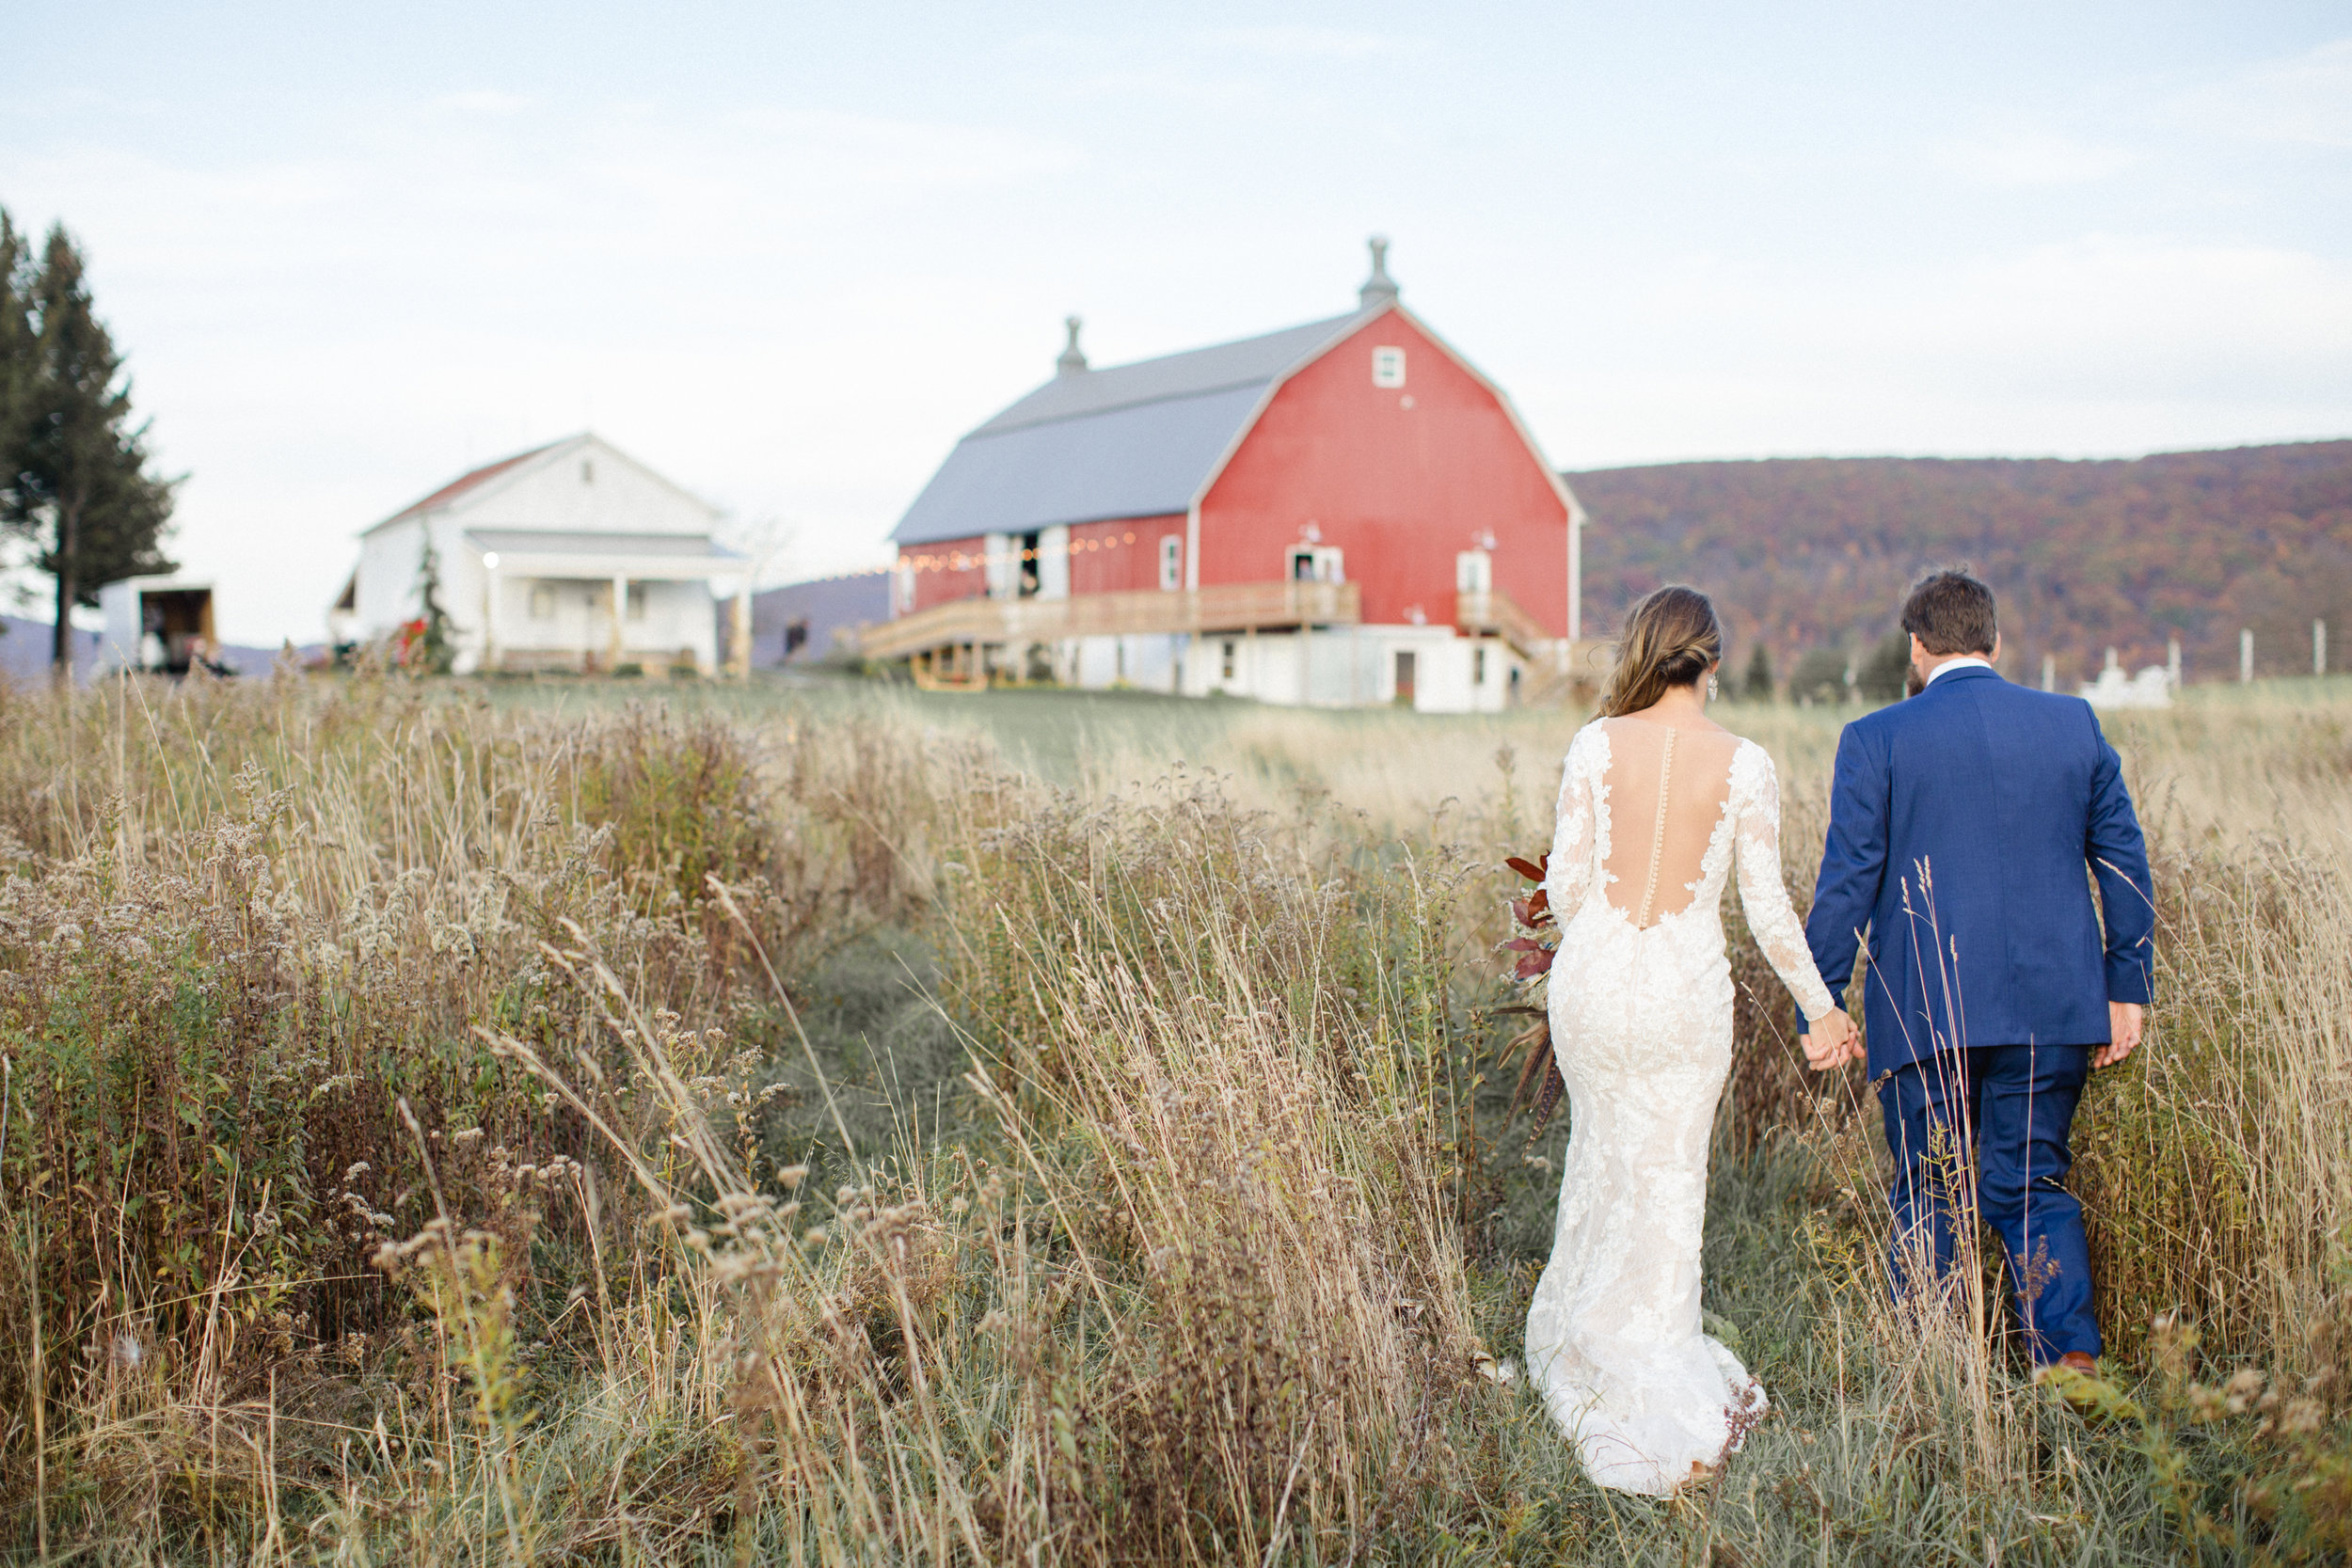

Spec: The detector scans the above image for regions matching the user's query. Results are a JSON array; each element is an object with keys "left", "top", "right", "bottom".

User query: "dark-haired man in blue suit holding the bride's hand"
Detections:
[{"left": 1800, "top": 571, "right": 2154, "bottom": 1375}]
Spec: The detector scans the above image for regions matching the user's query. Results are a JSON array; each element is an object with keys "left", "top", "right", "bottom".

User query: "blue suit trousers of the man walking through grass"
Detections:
[{"left": 1880, "top": 1046, "right": 2101, "bottom": 1366}]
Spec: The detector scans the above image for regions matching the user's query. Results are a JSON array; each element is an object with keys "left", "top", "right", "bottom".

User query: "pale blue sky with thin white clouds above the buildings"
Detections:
[{"left": 0, "top": 0, "right": 2352, "bottom": 644}]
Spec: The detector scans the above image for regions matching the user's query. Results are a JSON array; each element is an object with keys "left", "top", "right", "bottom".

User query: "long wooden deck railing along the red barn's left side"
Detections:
[{"left": 856, "top": 580, "right": 1364, "bottom": 658}]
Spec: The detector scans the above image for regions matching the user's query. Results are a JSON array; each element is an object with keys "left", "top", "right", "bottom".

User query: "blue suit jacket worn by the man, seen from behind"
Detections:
[{"left": 1804, "top": 668, "right": 2157, "bottom": 1077}]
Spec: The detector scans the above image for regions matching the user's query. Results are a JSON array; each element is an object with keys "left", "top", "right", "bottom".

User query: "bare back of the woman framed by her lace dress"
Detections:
[{"left": 1602, "top": 720, "right": 1740, "bottom": 931}]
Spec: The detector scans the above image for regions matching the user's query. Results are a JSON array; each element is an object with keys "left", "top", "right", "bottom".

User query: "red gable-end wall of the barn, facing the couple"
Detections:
[{"left": 1200, "top": 312, "right": 1569, "bottom": 637}]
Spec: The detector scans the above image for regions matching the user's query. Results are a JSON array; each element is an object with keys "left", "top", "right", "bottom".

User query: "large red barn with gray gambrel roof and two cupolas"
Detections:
[{"left": 861, "top": 240, "right": 1583, "bottom": 712}]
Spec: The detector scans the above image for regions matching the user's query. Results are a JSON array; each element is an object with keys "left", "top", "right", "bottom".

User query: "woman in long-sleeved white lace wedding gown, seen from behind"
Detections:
[{"left": 1527, "top": 588, "right": 1853, "bottom": 1497}]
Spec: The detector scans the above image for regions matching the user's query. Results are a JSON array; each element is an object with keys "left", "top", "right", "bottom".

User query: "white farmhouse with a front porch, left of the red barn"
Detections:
[{"left": 327, "top": 435, "right": 751, "bottom": 674}]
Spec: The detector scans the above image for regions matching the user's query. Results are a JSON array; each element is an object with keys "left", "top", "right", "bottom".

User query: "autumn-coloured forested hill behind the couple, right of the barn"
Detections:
[{"left": 1566, "top": 439, "right": 2352, "bottom": 679}]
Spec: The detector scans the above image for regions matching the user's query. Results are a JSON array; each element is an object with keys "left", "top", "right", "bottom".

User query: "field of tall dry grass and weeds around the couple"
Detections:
[{"left": 0, "top": 677, "right": 2352, "bottom": 1568}]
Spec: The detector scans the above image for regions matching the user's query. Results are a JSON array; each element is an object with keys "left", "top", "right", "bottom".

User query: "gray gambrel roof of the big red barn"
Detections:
[{"left": 892, "top": 306, "right": 1386, "bottom": 546}]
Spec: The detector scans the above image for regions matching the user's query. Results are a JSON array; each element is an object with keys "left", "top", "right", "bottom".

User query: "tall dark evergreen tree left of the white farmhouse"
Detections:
[{"left": 0, "top": 223, "right": 179, "bottom": 679}]
